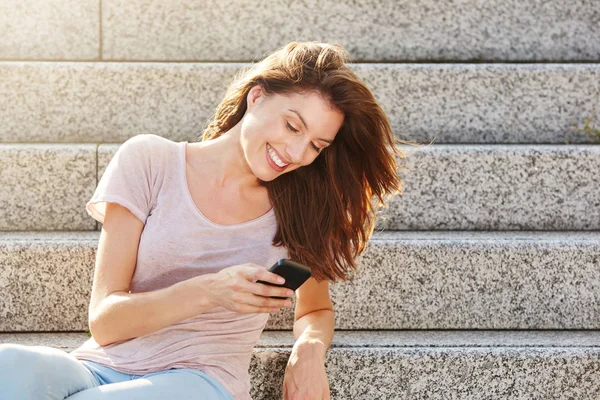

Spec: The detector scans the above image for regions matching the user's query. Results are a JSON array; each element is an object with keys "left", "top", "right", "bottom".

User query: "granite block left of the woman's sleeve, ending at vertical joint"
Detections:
[{"left": 0, "top": 143, "right": 97, "bottom": 231}]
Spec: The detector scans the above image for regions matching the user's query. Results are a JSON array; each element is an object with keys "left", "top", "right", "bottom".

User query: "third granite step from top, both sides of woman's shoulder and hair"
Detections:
[{"left": 0, "top": 143, "right": 600, "bottom": 231}]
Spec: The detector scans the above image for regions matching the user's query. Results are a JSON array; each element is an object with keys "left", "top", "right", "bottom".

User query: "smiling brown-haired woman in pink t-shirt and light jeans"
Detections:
[{"left": 0, "top": 42, "right": 408, "bottom": 400}]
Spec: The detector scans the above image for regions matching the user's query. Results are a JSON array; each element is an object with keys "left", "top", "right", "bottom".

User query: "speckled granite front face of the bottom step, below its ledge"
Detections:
[{"left": 250, "top": 347, "right": 600, "bottom": 400}]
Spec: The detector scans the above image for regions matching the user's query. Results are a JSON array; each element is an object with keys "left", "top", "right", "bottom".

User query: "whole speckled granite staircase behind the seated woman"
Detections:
[{"left": 0, "top": 0, "right": 600, "bottom": 400}]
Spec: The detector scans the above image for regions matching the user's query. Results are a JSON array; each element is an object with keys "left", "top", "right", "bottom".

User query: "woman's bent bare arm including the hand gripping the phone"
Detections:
[{"left": 88, "top": 203, "right": 294, "bottom": 346}]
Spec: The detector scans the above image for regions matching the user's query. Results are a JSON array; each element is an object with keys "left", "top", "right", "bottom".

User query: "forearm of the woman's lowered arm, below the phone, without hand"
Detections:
[{"left": 294, "top": 309, "right": 334, "bottom": 361}]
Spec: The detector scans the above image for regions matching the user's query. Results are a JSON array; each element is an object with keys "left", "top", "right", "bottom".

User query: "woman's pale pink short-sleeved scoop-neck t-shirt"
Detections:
[{"left": 70, "top": 134, "right": 288, "bottom": 400}]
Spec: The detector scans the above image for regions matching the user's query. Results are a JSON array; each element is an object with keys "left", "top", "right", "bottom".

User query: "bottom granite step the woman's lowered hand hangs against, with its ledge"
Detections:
[{"left": 0, "top": 330, "right": 600, "bottom": 400}]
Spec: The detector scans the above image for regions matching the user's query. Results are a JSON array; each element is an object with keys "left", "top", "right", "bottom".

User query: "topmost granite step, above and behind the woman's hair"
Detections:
[{"left": 0, "top": 0, "right": 600, "bottom": 61}]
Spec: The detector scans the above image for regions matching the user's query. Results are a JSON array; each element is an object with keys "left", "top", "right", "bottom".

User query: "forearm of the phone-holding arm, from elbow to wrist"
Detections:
[{"left": 89, "top": 274, "right": 215, "bottom": 346}]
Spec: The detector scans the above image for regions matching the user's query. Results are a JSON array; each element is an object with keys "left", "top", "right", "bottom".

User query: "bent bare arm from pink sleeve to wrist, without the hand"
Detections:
[{"left": 88, "top": 202, "right": 216, "bottom": 346}]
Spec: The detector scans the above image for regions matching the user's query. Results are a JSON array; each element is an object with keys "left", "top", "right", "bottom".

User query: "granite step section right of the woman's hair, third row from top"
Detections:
[{"left": 377, "top": 145, "right": 600, "bottom": 231}]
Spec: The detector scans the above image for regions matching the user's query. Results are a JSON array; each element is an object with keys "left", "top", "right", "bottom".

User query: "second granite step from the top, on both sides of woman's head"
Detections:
[{"left": 0, "top": 62, "right": 600, "bottom": 144}]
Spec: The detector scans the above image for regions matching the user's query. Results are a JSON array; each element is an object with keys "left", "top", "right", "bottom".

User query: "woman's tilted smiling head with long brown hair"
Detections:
[{"left": 203, "top": 42, "right": 414, "bottom": 282}]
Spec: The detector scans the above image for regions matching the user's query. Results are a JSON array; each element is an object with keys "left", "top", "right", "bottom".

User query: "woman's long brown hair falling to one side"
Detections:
[{"left": 202, "top": 42, "right": 420, "bottom": 282}]
